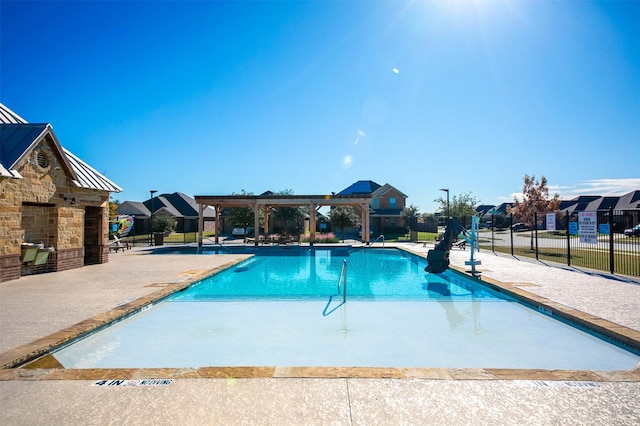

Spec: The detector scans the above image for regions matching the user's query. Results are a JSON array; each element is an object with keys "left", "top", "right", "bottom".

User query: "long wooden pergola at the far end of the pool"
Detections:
[{"left": 195, "top": 194, "right": 371, "bottom": 246}]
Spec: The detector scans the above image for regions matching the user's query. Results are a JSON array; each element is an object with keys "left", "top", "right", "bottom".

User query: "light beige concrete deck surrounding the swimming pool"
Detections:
[{"left": 0, "top": 243, "right": 640, "bottom": 425}]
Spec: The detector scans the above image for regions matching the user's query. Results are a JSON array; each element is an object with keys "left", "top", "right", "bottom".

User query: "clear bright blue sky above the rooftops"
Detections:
[{"left": 0, "top": 0, "right": 640, "bottom": 212}]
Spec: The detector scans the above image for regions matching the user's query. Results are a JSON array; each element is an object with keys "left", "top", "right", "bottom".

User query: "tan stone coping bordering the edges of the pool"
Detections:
[{"left": 0, "top": 247, "right": 640, "bottom": 382}]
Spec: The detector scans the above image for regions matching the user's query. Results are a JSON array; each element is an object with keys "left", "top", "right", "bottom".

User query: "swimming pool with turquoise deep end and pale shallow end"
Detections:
[{"left": 54, "top": 248, "right": 640, "bottom": 370}]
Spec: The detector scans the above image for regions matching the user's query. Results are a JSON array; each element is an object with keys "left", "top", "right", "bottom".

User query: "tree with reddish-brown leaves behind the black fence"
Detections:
[{"left": 507, "top": 175, "right": 560, "bottom": 250}]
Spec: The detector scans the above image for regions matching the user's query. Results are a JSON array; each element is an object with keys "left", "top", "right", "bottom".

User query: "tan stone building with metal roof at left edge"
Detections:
[{"left": 0, "top": 104, "right": 122, "bottom": 282}]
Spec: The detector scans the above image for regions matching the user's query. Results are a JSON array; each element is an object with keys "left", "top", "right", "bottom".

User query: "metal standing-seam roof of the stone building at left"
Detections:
[{"left": 0, "top": 103, "right": 122, "bottom": 192}]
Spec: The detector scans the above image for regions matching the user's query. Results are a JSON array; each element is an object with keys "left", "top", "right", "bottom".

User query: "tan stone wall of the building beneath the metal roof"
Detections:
[{"left": 0, "top": 135, "right": 109, "bottom": 282}]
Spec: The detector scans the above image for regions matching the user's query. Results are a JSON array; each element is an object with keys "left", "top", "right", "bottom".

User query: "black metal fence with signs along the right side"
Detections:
[{"left": 480, "top": 209, "right": 640, "bottom": 276}]
